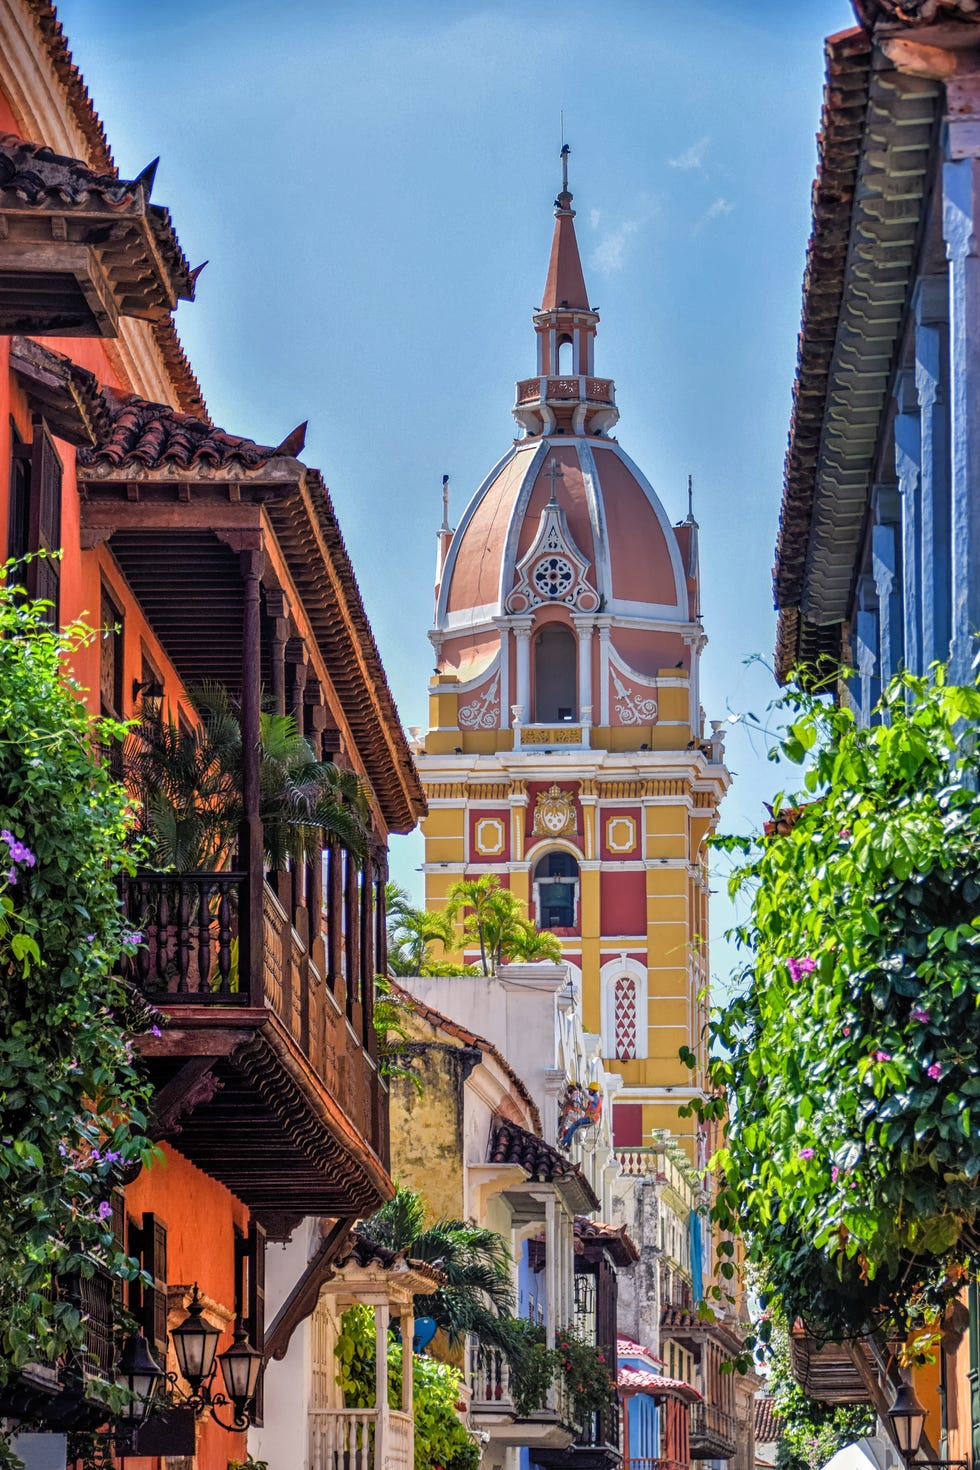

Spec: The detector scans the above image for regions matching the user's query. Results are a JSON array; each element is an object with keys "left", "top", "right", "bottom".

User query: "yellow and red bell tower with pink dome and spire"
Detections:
[{"left": 417, "top": 147, "right": 729, "bottom": 1157}]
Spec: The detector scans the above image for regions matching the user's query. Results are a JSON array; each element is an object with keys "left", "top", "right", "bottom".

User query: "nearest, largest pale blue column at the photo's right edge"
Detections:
[{"left": 943, "top": 149, "right": 980, "bottom": 682}]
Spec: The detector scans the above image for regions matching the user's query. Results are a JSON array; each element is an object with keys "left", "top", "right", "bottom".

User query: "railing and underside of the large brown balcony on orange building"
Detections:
[{"left": 126, "top": 869, "right": 391, "bottom": 1236}]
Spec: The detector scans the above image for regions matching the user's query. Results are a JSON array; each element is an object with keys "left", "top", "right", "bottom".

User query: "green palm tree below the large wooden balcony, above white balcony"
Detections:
[{"left": 359, "top": 1185, "right": 514, "bottom": 1354}]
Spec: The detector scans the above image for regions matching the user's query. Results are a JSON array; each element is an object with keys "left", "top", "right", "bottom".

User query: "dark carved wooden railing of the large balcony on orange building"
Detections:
[{"left": 126, "top": 870, "right": 385, "bottom": 1140}]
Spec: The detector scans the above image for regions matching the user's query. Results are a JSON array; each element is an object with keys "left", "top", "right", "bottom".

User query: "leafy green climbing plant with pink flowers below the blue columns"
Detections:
[{"left": 683, "top": 670, "right": 980, "bottom": 1348}]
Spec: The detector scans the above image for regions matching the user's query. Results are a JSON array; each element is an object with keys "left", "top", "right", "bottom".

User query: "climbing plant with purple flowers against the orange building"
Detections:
[{"left": 0, "top": 567, "right": 153, "bottom": 1463}]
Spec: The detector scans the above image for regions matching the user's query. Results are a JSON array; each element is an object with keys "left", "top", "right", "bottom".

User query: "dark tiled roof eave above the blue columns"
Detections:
[{"left": 773, "top": 32, "right": 937, "bottom": 679}]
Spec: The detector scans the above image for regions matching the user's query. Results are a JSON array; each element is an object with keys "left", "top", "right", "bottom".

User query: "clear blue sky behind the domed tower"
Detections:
[{"left": 59, "top": 0, "right": 854, "bottom": 970}]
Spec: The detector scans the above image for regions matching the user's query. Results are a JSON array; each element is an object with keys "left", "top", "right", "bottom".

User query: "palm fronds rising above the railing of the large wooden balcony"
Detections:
[{"left": 126, "top": 684, "right": 369, "bottom": 873}]
